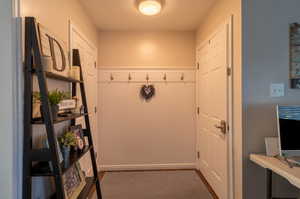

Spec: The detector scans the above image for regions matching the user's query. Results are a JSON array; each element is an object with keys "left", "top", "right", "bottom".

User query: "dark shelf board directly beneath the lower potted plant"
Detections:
[{"left": 31, "top": 146, "right": 93, "bottom": 176}]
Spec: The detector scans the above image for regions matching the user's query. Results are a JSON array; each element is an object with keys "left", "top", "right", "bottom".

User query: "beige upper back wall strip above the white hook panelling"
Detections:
[{"left": 98, "top": 31, "right": 195, "bottom": 67}]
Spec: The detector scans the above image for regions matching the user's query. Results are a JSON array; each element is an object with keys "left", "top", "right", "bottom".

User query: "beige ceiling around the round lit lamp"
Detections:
[{"left": 80, "top": 0, "right": 217, "bottom": 31}]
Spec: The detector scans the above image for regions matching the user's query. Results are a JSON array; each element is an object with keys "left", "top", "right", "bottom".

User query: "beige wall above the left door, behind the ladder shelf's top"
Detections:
[{"left": 21, "top": 0, "right": 98, "bottom": 46}]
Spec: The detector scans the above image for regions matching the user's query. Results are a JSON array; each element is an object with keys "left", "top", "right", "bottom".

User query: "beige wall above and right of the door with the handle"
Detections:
[{"left": 197, "top": 0, "right": 243, "bottom": 199}]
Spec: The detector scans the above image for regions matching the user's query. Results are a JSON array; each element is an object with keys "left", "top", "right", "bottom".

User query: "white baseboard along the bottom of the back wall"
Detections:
[{"left": 99, "top": 163, "right": 196, "bottom": 171}]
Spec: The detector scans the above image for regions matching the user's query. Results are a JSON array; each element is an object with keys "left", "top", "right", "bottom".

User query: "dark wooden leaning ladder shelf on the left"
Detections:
[{"left": 23, "top": 17, "right": 102, "bottom": 199}]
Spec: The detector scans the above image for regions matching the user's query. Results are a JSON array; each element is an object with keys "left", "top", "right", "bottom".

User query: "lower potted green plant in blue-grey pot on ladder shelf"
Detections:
[{"left": 59, "top": 131, "right": 77, "bottom": 165}]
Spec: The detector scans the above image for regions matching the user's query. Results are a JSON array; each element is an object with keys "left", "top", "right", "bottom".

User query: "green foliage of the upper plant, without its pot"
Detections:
[{"left": 33, "top": 89, "right": 70, "bottom": 105}]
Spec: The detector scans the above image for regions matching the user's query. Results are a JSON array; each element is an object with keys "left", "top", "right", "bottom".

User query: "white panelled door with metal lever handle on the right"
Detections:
[{"left": 197, "top": 17, "right": 231, "bottom": 199}]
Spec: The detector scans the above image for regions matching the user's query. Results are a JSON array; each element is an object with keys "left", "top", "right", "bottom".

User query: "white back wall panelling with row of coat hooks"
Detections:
[{"left": 98, "top": 69, "right": 196, "bottom": 170}]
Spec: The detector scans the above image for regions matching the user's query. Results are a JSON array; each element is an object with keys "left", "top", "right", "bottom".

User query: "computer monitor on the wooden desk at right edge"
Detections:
[{"left": 277, "top": 105, "right": 300, "bottom": 157}]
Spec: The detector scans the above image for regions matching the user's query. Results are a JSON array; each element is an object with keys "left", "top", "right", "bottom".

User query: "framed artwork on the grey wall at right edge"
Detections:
[{"left": 290, "top": 23, "right": 300, "bottom": 89}]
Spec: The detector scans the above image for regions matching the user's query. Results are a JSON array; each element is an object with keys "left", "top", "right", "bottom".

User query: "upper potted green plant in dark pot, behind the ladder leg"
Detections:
[{"left": 34, "top": 89, "right": 70, "bottom": 120}]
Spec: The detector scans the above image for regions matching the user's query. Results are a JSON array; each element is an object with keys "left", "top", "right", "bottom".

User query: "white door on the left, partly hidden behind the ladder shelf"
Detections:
[{"left": 70, "top": 24, "right": 98, "bottom": 173}]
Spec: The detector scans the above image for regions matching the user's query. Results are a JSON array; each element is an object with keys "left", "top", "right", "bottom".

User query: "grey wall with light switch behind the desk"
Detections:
[{"left": 243, "top": 0, "right": 300, "bottom": 199}]
